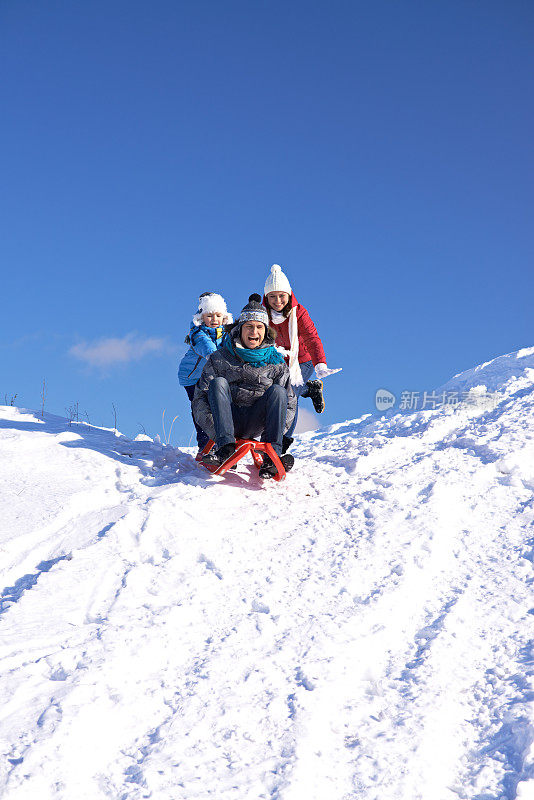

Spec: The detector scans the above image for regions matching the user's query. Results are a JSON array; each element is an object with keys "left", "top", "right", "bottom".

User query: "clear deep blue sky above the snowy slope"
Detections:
[{"left": 0, "top": 0, "right": 534, "bottom": 443}]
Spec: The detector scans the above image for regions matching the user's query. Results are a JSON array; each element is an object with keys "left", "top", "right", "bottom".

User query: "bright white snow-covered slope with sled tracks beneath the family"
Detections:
[{"left": 0, "top": 351, "right": 534, "bottom": 800}]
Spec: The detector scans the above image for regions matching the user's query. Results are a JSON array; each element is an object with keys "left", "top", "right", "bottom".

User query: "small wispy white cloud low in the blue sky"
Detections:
[{"left": 69, "top": 333, "right": 173, "bottom": 367}]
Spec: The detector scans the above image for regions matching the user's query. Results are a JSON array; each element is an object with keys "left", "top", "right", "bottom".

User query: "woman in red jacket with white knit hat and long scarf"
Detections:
[{"left": 263, "top": 264, "right": 328, "bottom": 450}]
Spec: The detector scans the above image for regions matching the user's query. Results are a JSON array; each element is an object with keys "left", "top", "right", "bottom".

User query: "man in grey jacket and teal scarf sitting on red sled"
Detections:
[{"left": 192, "top": 301, "right": 297, "bottom": 478}]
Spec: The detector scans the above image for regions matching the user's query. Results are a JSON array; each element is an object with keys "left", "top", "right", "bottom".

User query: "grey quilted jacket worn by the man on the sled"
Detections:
[{"left": 192, "top": 326, "right": 297, "bottom": 439}]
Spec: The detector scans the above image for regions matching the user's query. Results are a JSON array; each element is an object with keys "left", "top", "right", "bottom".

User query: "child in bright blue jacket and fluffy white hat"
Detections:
[{"left": 178, "top": 292, "right": 234, "bottom": 450}]
